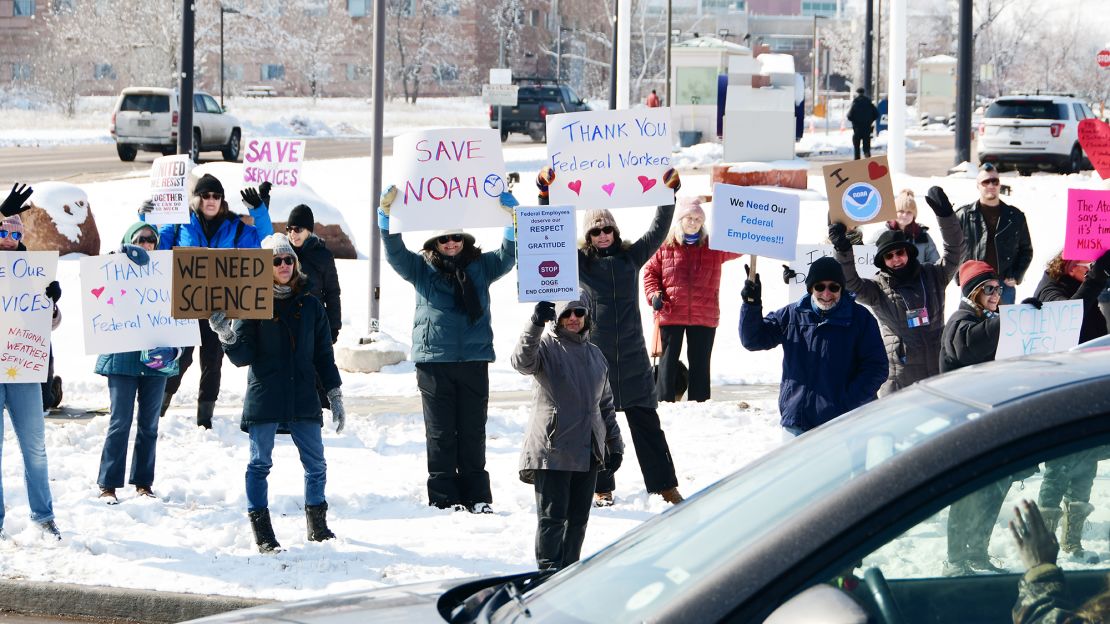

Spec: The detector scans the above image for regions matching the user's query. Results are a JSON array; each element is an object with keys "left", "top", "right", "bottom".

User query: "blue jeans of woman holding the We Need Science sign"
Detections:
[{"left": 246, "top": 421, "right": 327, "bottom": 512}]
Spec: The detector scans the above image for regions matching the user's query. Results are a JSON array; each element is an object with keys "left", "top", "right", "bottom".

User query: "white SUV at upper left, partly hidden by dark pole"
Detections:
[{"left": 110, "top": 87, "right": 243, "bottom": 162}]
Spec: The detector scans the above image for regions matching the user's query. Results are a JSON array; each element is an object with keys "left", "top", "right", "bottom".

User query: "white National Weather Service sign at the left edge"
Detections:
[{"left": 0, "top": 251, "right": 58, "bottom": 383}]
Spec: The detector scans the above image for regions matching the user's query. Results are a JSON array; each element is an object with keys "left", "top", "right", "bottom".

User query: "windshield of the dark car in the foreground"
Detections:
[{"left": 508, "top": 388, "right": 977, "bottom": 623}]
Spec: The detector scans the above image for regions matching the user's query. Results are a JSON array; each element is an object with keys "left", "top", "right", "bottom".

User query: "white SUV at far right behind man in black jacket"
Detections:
[{"left": 977, "top": 94, "right": 1096, "bottom": 174}]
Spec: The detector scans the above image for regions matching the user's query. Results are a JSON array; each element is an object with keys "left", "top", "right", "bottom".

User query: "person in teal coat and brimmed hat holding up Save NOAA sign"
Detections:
[{"left": 377, "top": 184, "right": 516, "bottom": 513}]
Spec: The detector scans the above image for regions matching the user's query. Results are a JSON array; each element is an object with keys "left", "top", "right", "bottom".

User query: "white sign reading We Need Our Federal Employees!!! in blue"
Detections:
[{"left": 708, "top": 184, "right": 800, "bottom": 260}]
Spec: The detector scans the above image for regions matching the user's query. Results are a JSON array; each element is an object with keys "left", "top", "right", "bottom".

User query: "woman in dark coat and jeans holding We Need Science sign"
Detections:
[{"left": 210, "top": 234, "right": 346, "bottom": 554}]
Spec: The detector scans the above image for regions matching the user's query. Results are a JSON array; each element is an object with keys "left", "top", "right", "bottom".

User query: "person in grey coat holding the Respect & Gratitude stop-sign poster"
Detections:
[{"left": 511, "top": 293, "right": 624, "bottom": 570}]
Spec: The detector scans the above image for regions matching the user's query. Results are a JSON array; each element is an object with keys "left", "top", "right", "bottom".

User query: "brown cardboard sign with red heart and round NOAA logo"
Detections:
[{"left": 821, "top": 157, "right": 895, "bottom": 228}]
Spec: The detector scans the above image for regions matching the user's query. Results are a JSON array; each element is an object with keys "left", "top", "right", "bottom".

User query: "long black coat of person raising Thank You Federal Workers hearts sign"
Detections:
[{"left": 578, "top": 204, "right": 675, "bottom": 411}]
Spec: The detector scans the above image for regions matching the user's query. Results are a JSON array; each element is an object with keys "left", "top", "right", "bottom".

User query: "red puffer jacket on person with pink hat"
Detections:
[{"left": 644, "top": 240, "right": 740, "bottom": 328}]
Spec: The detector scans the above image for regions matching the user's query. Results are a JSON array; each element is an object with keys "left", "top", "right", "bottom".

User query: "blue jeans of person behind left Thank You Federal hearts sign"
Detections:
[{"left": 97, "top": 375, "right": 165, "bottom": 489}]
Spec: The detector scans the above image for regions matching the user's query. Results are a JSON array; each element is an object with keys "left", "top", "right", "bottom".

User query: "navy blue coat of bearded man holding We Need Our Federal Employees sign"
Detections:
[{"left": 740, "top": 293, "right": 887, "bottom": 431}]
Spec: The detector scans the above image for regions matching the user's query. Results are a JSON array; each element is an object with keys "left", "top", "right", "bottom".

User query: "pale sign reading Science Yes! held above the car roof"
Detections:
[{"left": 995, "top": 300, "right": 1083, "bottom": 360}]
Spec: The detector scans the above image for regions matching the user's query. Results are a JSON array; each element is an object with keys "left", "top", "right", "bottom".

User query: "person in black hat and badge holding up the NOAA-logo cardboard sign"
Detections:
[{"left": 829, "top": 187, "right": 963, "bottom": 396}]
